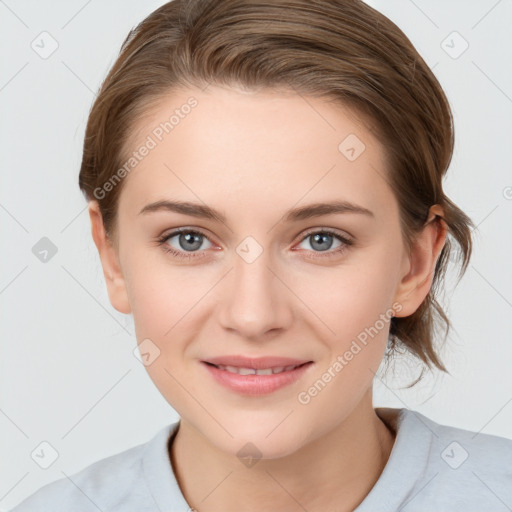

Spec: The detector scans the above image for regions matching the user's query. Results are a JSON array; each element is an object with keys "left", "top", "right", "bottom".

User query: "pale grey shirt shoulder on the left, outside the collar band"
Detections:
[{"left": 11, "top": 425, "right": 178, "bottom": 512}]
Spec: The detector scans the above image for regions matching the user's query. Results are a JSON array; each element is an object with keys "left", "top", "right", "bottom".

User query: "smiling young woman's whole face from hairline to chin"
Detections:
[{"left": 103, "top": 86, "right": 417, "bottom": 458}]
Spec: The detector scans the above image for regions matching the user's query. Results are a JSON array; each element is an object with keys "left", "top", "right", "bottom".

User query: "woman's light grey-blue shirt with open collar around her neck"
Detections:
[{"left": 11, "top": 408, "right": 512, "bottom": 512}]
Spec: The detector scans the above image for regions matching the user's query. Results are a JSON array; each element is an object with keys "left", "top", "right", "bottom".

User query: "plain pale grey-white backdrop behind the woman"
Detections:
[{"left": 0, "top": 0, "right": 512, "bottom": 509}]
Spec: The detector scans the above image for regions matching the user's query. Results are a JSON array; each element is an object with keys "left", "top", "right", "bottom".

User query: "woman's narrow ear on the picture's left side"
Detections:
[{"left": 89, "top": 200, "right": 131, "bottom": 314}]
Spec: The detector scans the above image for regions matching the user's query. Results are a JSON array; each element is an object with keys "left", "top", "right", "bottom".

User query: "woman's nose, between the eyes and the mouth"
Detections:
[{"left": 219, "top": 247, "right": 294, "bottom": 340}]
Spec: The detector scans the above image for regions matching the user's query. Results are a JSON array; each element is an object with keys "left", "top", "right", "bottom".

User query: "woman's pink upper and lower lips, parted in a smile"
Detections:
[{"left": 201, "top": 356, "right": 313, "bottom": 396}]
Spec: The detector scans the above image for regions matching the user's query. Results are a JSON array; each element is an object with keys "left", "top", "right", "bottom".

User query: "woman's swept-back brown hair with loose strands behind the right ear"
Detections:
[{"left": 79, "top": 0, "right": 474, "bottom": 382}]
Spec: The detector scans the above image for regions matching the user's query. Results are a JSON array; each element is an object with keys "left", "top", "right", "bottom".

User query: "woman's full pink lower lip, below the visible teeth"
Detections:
[{"left": 201, "top": 361, "right": 313, "bottom": 395}]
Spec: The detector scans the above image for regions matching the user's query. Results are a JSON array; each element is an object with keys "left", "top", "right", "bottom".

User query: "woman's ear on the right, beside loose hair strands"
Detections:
[{"left": 395, "top": 204, "right": 448, "bottom": 317}]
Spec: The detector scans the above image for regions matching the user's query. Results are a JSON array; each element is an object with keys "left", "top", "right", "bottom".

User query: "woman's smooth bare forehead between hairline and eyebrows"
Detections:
[{"left": 120, "top": 85, "right": 396, "bottom": 224}]
